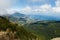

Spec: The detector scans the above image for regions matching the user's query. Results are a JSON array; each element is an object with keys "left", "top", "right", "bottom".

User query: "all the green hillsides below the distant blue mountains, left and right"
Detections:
[{"left": 0, "top": 16, "right": 60, "bottom": 40}]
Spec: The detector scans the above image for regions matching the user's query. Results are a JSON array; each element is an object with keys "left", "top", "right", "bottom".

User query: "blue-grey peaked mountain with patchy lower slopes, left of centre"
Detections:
[{"left": 8, "top": 12, "right": 32, "bottom": 24}]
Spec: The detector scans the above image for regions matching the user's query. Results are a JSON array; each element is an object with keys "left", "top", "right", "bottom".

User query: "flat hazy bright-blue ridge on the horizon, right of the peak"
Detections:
[{"left": 29, "top": 14, "right": 60, "bottom": 21}]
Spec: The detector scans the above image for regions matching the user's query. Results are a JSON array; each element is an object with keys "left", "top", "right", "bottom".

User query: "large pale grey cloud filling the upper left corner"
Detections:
[{"left": 0, "top": 0, "right": 16, "bottom": 15}]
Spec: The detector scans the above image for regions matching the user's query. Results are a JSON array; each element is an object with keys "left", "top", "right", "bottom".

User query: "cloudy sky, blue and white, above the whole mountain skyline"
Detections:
[{"left": 0, "top": 0, "right": 60, "bottom": 17}]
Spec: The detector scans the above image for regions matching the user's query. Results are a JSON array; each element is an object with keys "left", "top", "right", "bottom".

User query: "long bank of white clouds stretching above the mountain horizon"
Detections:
[{"left": 8, "top": 4, "right": 60, "bottom": 15}]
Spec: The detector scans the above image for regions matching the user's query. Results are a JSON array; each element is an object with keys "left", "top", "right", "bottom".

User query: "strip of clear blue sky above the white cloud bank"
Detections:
[{"left": 13, "top": 0, "right": 56, "bottom": 8}]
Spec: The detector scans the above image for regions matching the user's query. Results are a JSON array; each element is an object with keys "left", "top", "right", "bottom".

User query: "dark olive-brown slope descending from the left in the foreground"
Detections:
[{"left": 0, "top": 16, "right": 36, "bottom": 40}]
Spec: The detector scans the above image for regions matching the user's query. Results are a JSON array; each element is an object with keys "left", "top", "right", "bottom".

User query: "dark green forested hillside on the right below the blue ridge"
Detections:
[{"left": 26, "top": 21, "right": 60, "bottom": 40}]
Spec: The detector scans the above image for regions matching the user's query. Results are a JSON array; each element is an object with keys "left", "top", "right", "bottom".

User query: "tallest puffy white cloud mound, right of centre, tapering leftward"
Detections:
[{"left": 34, "top": 4, "right": 51, "bottom": 13}]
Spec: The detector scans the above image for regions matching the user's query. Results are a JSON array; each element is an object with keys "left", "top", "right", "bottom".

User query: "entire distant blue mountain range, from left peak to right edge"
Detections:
[{"left": 5, "top": 12, "right": 60, "bottom": 24}]
